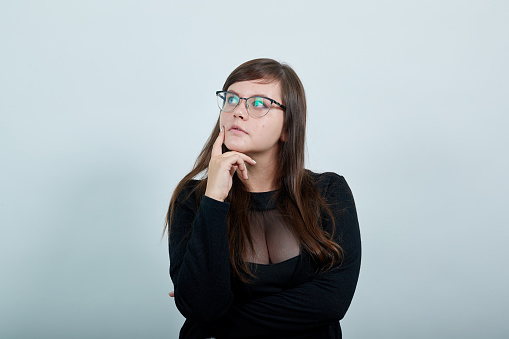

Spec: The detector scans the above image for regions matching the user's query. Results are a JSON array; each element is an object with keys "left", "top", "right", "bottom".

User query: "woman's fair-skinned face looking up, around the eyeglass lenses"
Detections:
[{"left": 220, "top": 81, "right": 284, "bottom": 157}]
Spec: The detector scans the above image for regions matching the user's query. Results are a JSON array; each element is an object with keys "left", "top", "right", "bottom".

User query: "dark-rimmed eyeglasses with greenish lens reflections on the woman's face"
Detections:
[{"left": 216, "top": 91, "right": 286, "bottom": 118}]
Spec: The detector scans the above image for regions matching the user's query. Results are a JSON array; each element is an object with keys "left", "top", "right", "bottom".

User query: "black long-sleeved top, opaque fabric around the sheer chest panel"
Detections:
[{"left": 169, "top": 171, "right": 361, "bottom": 338}]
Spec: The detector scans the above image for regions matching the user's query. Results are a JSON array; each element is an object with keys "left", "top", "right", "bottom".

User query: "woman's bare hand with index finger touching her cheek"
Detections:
[{"left": 205, "top": 126, "right": 256, "bottom": 201}]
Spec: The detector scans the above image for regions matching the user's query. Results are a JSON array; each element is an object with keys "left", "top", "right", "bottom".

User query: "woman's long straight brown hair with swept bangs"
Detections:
[{"left": 163, "top": 59, "right": 343, "bottom": 281}]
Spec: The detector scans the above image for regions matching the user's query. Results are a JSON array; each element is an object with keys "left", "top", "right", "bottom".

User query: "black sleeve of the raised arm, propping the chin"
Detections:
[{"left": 169, "top": 190, "right": 233, "bottom": 323}]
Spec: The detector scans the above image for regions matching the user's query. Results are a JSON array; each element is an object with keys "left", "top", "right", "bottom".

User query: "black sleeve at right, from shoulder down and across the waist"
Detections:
[{"left": 214, "top": 173, "right": 361, "bottom": 338}]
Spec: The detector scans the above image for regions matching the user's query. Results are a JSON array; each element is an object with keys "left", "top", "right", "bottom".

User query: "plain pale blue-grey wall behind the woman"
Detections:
[{"left": 0, "top": 0, "right": 509, "bottom": 338}]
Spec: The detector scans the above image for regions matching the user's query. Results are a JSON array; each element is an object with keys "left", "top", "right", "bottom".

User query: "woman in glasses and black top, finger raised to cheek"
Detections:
[{"left": 167, "top": 59, "right": 361, "bottom": 338}]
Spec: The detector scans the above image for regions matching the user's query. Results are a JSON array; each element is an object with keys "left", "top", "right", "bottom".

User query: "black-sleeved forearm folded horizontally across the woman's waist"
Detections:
[{"left": 214, "top": 262, "right": 359, "bottom": 338}]
